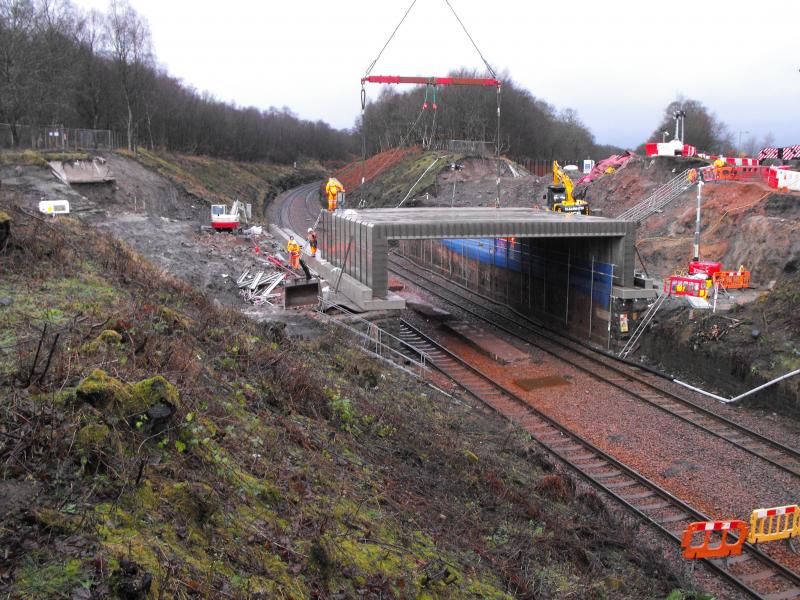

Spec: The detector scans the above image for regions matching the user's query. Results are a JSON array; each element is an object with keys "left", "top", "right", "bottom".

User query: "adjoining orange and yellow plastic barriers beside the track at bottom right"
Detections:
[{"left": 681, "top": 504, "right": 800, "bottom": 559}]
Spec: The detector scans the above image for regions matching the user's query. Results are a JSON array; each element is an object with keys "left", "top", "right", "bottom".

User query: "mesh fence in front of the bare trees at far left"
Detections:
[{"left": 0, "top": 123, "right": 120, "bottom": 151}]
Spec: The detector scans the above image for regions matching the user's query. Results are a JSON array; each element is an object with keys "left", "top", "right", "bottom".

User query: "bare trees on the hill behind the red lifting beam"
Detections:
[{"left": 357, "top": 70, "right": 620, "bottom": 160}]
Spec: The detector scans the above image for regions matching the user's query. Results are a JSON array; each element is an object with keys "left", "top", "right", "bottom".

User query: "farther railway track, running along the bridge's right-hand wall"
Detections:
[{"left": 389, "top": 257, "right": 800, "bottom": 477}]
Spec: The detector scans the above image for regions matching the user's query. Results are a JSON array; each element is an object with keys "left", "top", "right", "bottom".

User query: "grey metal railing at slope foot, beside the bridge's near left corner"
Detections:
[{"left": 317, "top": 300, "right": 430, "bottom": 379}]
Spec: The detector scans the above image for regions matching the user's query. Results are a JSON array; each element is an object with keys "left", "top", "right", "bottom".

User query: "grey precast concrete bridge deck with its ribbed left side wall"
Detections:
[{"left": 319, "top": 208, "right": 637, "bottom": 299}]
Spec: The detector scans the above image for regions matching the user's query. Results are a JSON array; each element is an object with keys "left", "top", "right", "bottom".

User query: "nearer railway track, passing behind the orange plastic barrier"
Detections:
[{"left": 400, "top": 321, "right": 800, "bottom": 600}]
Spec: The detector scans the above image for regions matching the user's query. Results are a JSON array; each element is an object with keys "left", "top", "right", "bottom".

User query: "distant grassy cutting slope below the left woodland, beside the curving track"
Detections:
[{"left": 120, "top": 148, "right": 326, "bottom": 216}]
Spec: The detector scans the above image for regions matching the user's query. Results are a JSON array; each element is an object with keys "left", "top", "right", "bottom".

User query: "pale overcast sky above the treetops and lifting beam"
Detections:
[{"left": 75, "top": 0, "right": 800, "bottom": 146}]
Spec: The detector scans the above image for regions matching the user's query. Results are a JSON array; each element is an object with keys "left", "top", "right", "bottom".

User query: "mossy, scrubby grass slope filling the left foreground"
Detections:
[{"left": 0, "top": 198, "right": 700, "bottom": 598}]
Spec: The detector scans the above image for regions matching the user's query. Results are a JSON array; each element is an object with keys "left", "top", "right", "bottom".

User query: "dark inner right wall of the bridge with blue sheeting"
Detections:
[{"left": 396, "top": 238, "right": 614, "bottom": 347}]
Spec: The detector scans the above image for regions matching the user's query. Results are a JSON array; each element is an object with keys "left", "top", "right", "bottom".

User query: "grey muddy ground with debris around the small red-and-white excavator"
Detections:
[{"left": 0, "top": 153, "right": 318, "bottom": 335}]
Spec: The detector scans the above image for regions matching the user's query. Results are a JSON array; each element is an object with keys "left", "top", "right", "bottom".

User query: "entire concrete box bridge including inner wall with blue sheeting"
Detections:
[{"left": 318, "top": 208, "right": 655, "bottom": 343}]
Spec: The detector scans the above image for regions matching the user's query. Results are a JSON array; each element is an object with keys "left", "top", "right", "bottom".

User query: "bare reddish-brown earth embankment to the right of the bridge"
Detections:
[{"left": 584, "top": 159, "right": 800, "bottom": 414}]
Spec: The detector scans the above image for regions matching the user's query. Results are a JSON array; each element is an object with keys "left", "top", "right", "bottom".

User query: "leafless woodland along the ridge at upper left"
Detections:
[{"left": 0, "top": 0, "right": 353, "bottom": 162}]
